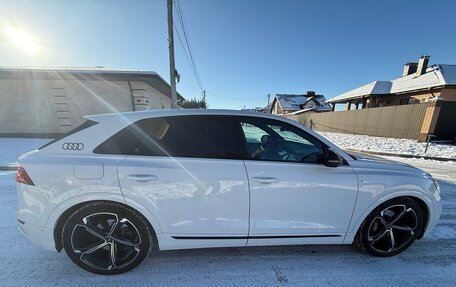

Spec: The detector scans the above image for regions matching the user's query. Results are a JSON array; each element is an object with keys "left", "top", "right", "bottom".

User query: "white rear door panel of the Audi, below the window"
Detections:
[{"left": 118, "top": 156, "right": 249, "bottom": 249}]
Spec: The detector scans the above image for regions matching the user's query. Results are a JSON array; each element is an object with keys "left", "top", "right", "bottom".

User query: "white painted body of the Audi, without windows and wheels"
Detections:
[{"left": 17, "top": 110, "right": 441, "bottom": 253}]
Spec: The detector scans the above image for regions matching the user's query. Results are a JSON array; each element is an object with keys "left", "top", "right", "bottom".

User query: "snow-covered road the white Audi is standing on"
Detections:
[{"left": 0, "top": 158, "right": 456, "bottom": 287}]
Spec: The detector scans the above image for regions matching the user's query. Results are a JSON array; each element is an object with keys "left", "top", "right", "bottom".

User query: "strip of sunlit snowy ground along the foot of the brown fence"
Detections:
[{"left": 319, "top": 132, "right": 456, "bottom": 159}]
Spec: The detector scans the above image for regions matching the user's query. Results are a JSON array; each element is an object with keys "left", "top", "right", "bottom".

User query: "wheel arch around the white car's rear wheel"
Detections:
[{"left": 48, "top": 198, "right": 161, "bottom": 252}]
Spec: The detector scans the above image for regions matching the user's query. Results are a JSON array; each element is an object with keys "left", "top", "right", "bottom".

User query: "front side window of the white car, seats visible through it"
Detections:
[{"left": 239, "top": 117, "right": 324, "bottom": 163}]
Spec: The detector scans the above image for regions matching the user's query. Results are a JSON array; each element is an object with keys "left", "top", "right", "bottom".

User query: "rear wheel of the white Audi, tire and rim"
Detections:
[{"left": 62, "top": 202, "right": 158, "bottom": 275}]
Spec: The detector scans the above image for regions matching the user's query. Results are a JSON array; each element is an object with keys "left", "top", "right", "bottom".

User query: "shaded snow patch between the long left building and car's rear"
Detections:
[{"left": 0, "top": 138, "right": 50, "bottom": 166}]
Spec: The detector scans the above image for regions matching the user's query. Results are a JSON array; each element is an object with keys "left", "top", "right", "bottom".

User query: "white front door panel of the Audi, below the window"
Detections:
[{"left": 245, "top": 161, "right": 358, "bottom": 243}]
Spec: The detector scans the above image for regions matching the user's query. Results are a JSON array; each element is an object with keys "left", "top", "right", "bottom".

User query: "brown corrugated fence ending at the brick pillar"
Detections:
[{"left": 287, "top": 103, "right": 435, "bottom": 140}]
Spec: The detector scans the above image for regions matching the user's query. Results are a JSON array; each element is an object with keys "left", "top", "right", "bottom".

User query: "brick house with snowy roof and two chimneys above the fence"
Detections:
[{"left": 326, "top": 56, "right": 456, "bottom": 111}]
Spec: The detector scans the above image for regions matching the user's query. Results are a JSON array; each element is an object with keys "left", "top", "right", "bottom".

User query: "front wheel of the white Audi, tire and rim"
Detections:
[{"left": 357, "top": 197, "right": 424, "bottom": 257}]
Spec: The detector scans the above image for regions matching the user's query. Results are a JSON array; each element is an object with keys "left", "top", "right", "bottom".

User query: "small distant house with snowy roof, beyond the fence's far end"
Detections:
[{"left": 270, "top": 91, "right": 330, "bottom": 115}]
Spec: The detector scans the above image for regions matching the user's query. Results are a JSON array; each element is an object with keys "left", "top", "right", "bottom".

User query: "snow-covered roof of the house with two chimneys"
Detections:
[{"left": 326, "top": 65, "right": 456, "bottom": 103}]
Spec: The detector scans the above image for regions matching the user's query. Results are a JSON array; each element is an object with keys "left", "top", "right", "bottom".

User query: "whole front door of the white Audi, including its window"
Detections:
[{"left": 235, "top": 117, "right": 358, "bottom": 245}]
